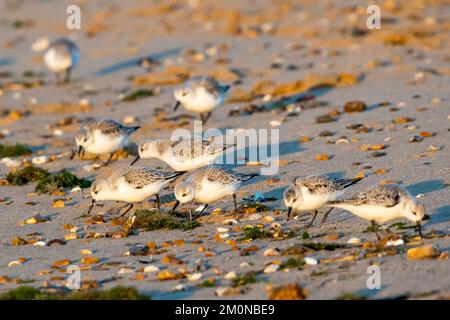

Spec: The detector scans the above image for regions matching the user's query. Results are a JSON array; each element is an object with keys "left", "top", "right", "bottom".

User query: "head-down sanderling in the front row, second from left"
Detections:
[{"left": 172, "top": 166, "right": 258, "bottom": 219}]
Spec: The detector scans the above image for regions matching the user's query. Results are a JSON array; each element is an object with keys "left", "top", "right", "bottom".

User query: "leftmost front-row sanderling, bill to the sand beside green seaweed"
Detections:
[{"left": 87, "top": 167, "right": 184, "bottom": 216}]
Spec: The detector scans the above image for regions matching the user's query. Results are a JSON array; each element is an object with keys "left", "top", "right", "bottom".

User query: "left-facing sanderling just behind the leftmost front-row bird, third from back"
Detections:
[{"left": 72, "top": 118, "right": 140, "bottom": 165}]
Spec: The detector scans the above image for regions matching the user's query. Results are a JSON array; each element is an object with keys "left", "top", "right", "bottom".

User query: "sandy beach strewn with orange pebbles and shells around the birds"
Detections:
[{"left": 0, "top": 0, "right": 450, "bottom": 299}]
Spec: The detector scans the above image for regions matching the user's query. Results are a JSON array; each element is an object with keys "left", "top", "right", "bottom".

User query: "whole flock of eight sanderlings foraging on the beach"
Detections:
[{"left": 44, "top": 39, "right": 428, "bottom": 237}]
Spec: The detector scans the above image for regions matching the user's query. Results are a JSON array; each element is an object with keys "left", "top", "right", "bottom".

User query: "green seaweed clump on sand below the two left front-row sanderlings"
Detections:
[{"left": 132, "top": 210, "right": 200, "bottom": 231}]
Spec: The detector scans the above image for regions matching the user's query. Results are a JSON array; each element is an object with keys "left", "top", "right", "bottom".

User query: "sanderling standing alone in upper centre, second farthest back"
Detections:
[{"left": 174, "top": 77, "right": 230, "bottom": 123}]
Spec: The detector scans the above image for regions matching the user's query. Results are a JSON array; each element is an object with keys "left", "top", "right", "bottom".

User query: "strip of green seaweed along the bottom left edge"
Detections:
[{"left": 0, "top": 286, "right": 150, "bottom": 300}]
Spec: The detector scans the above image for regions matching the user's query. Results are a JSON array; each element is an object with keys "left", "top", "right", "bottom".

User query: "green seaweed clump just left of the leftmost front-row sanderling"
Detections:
[{"left": 36, "top": 169, "right": 92, "bottom": 193}]
